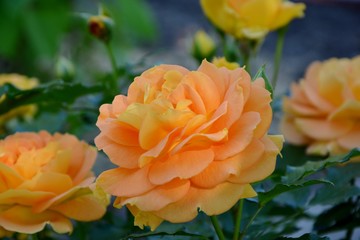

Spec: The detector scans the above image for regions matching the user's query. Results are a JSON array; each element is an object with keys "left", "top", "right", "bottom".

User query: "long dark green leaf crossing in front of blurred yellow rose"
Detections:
[{"left": 0, "top": 81, "right": 102, "bottom": 114}]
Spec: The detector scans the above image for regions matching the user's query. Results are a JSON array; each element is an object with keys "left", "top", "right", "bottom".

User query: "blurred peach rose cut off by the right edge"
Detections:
[{"left": 281, "top": 56, "right": 360, "bottom": 158}]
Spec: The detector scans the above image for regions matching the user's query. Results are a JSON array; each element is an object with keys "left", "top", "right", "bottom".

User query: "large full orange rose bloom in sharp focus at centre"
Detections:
[{"left": 95, "top": 61, "right": 282, "bottom": 229}]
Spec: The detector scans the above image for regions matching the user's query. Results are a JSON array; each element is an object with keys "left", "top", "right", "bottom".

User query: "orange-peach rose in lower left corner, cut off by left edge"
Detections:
[{"left": 0, "top": 131, "right": 107, "bottom": 234}]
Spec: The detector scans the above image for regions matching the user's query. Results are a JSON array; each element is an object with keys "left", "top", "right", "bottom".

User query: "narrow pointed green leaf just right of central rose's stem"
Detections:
[{"left": 258, "top": 180, "right": 332, "bottom": 206}]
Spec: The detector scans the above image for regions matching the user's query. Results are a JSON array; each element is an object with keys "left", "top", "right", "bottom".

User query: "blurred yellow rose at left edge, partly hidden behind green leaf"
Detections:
[{"left": 0, "top": 74, "right": 38, "bottom": 132}]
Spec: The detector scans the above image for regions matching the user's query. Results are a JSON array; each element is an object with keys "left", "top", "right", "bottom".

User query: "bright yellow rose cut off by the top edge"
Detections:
[{"left": 200, "top": 0, "right": 305, "bottom": 39}]
